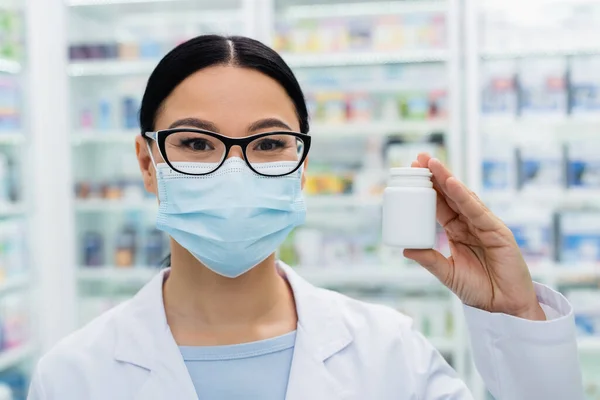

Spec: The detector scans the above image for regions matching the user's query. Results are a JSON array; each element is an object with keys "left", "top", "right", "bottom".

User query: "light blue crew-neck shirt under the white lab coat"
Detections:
[{"left": 179, "top": 331, "right": 296, "bottom": 400}]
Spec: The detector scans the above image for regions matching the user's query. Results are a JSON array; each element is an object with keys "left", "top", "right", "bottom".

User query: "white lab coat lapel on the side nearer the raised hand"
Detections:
[{"left": 279, "top": 263, "right": 352, "bottom": 400}]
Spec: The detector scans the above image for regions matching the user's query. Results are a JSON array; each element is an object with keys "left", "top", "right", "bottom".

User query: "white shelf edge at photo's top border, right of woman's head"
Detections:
[{"left": 283, "top": 0, "right": 447, "bottom": 20}]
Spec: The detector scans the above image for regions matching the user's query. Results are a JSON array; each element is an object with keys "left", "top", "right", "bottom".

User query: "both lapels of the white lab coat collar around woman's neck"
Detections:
[{"left": 114, "top": 263, "right": 352, "bottom": 400}]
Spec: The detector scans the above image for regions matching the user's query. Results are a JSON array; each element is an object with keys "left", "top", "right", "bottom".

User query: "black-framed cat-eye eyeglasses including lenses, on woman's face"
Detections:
[{"left": 142, "top": 128, "right": 311, "bottom": 176}]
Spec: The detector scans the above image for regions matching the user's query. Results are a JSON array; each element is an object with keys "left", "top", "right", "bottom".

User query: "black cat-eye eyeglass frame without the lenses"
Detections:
[{"left": 142, "top": 128, "right": 311, "bottom": 178}]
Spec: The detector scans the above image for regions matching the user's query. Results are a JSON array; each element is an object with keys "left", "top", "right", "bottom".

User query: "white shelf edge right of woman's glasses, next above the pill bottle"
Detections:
[{"left": 310, "top": 120, "right": 448, "bottom": 139}]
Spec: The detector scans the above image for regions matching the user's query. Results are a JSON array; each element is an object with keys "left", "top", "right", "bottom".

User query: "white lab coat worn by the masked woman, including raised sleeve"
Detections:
[{"left": 29, "top": 265, "right": 583, "bottom": 400}]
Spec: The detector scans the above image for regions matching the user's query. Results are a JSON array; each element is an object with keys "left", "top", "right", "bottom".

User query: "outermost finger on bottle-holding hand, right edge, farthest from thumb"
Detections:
[{"left": 446, "top": 177, "right": 499, "bottom": 230}]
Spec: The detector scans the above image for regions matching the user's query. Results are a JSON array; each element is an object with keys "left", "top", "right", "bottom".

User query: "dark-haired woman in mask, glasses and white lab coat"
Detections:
[{"left": 30, "top": 36, "right": 583, "bottom": 400}]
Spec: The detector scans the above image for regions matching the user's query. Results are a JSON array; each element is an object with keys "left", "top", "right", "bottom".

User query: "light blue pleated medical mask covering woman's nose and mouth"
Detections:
[{"left": 155, "top": 157, "right": 306, "bottom": 278}]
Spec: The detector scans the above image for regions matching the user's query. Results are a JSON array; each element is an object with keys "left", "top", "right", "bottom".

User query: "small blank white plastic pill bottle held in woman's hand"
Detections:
[{"left": 382, "top": 168, "right": 437, "bottom": 249}]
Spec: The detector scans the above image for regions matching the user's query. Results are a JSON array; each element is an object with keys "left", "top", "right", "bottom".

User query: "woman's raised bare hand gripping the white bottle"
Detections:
[{"left": 404, "top": 154, "right": 546, "bottom": 320}]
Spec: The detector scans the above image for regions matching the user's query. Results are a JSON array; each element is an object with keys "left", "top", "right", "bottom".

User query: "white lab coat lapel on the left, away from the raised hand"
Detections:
[{"left": 115, "top": 270, "right": 198, "bottom": 400}]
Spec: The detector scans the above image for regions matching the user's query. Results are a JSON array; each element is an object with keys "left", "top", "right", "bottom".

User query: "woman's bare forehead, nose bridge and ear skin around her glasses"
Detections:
[{"left": 136, "top": 66, "right": 304, "bottom": 194}]
